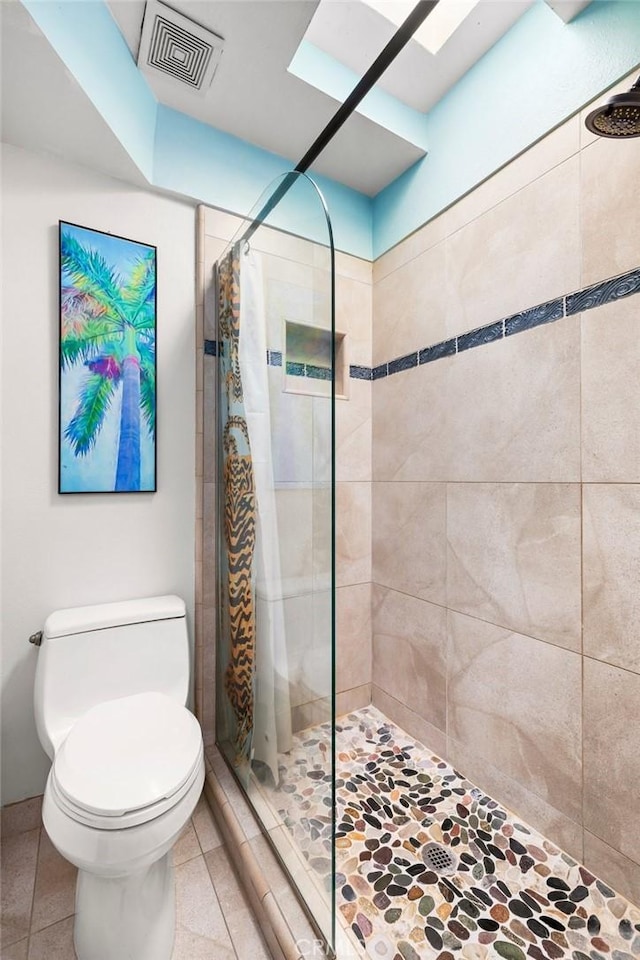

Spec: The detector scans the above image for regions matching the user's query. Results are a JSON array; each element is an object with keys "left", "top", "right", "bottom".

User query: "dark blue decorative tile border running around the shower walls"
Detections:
[{"left": 204, "top": 267, "right": 640, "bottom": 380}]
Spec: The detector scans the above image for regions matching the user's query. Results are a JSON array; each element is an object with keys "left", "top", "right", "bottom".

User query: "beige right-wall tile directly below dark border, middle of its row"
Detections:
[{"left": 448, "top": 317, "right": 580, "bottom": 482}]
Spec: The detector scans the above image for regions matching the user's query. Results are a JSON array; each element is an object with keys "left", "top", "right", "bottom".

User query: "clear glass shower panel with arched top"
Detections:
[{"left": 216, "top": 174, "right": 336, "bottom": 944}]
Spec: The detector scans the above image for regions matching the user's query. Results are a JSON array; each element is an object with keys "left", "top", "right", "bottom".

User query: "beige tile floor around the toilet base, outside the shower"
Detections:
[{"left": 0, "top": 798, "right": 270, "bottom": 960}]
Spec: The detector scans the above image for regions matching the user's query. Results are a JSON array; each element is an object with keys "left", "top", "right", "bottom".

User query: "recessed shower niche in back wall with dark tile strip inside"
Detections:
[{"left": 283, "top": 320, "right": 349, "bottom": 399}]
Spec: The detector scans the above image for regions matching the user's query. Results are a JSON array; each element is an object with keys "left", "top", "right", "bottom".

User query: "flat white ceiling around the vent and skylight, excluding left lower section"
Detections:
[{"left": 108, "top": 0, "right": 534, "bottom": 196}]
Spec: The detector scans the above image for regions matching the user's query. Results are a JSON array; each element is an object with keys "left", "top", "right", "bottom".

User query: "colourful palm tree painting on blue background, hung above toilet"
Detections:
[{"left": 59, "top": 221, "right": 156, "bottom": 493}]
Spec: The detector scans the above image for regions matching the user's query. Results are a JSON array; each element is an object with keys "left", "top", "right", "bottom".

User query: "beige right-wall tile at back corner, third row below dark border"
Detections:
[{"left": 373, "top": 585, "right": 447, "bottom": 731}]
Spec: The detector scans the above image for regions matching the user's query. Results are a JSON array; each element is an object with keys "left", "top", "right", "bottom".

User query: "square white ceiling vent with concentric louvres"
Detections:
[{"left": 138, "top": 0, "right": 224, "bottom": 94}]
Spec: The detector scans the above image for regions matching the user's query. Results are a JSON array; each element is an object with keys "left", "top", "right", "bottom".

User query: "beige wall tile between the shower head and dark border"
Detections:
[{"left": 580, "top": 138, "right": 640, "bottom": 285}]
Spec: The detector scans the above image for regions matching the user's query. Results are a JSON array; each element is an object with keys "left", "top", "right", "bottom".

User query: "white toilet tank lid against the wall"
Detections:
[{"left": 44, "top": 596, "right": 185, "bottom": 639}]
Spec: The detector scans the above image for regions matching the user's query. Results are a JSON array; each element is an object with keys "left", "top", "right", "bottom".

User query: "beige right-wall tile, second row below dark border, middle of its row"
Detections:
[{"left": 447, "top": 483, "right": 581, "bottom": 651}]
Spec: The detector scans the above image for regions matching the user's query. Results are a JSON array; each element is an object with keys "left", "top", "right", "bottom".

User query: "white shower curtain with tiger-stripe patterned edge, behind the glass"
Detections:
[{"left": 218, "top": 244, "right": 292, "bottom": 785}]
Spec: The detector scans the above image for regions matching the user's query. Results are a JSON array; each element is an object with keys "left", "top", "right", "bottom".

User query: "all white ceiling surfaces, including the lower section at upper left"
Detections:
[{"left": 0, "top": 0, "right": 585, "bottom": 196}]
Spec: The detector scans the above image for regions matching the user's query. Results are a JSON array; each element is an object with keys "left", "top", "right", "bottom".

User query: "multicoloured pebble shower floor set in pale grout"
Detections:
[{"left": 272, "top": 707, "right": 640, "bottom": 960}]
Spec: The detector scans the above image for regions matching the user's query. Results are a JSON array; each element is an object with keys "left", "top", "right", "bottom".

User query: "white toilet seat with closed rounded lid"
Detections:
[{"left": 49, "top": 692, "right": 203, "bottom": 830}]
